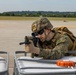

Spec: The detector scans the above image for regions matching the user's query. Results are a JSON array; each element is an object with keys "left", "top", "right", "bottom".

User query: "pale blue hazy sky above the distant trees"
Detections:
[{"left": 0, "top": 0, "right": 76, "bottom": 13}]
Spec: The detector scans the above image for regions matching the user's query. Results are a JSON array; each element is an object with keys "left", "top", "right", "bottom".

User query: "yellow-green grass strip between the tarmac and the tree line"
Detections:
[{"left": 0, "top": 16, "right": 76, "bottom": 21}]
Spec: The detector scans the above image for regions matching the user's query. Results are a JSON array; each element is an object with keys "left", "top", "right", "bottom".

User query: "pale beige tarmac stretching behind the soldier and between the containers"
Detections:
[{"left": 0, "top": 20, "right": 76, "bottom": 75}]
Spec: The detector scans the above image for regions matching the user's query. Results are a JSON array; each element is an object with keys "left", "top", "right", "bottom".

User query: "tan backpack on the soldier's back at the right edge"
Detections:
[{"left": 54, "top": 27, "right": 76, "bottom": 50}]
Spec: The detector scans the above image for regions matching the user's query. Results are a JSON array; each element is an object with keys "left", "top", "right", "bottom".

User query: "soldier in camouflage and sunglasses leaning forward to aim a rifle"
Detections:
[{"left": 25, "top": 18, "right": 73, "bottom": 59}]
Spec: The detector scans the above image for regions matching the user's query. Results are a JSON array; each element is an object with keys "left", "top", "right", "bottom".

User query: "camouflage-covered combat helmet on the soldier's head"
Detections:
[{"left": 31, "top": 18, "right": 53, "bottom": 32}]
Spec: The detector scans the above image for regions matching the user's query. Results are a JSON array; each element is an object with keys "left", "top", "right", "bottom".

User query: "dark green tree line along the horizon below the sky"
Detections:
[{"left": 0, "top": 11, "right": 76, "bottom": 18}]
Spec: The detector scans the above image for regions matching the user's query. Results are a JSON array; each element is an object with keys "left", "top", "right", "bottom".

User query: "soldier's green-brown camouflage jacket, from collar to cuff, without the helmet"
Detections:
[{"left": 39, "top": 32, "right": 73, "bottom": 59}]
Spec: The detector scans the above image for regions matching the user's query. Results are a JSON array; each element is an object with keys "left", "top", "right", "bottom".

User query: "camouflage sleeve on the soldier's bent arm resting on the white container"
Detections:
[{"left": 40, "top": 35, "right": 70, "bottom": 59}]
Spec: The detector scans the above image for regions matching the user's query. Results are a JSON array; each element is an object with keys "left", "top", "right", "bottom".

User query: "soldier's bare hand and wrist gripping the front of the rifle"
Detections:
[{"left": 25, "top": 40, "right": 40, "bottom": 54}]
